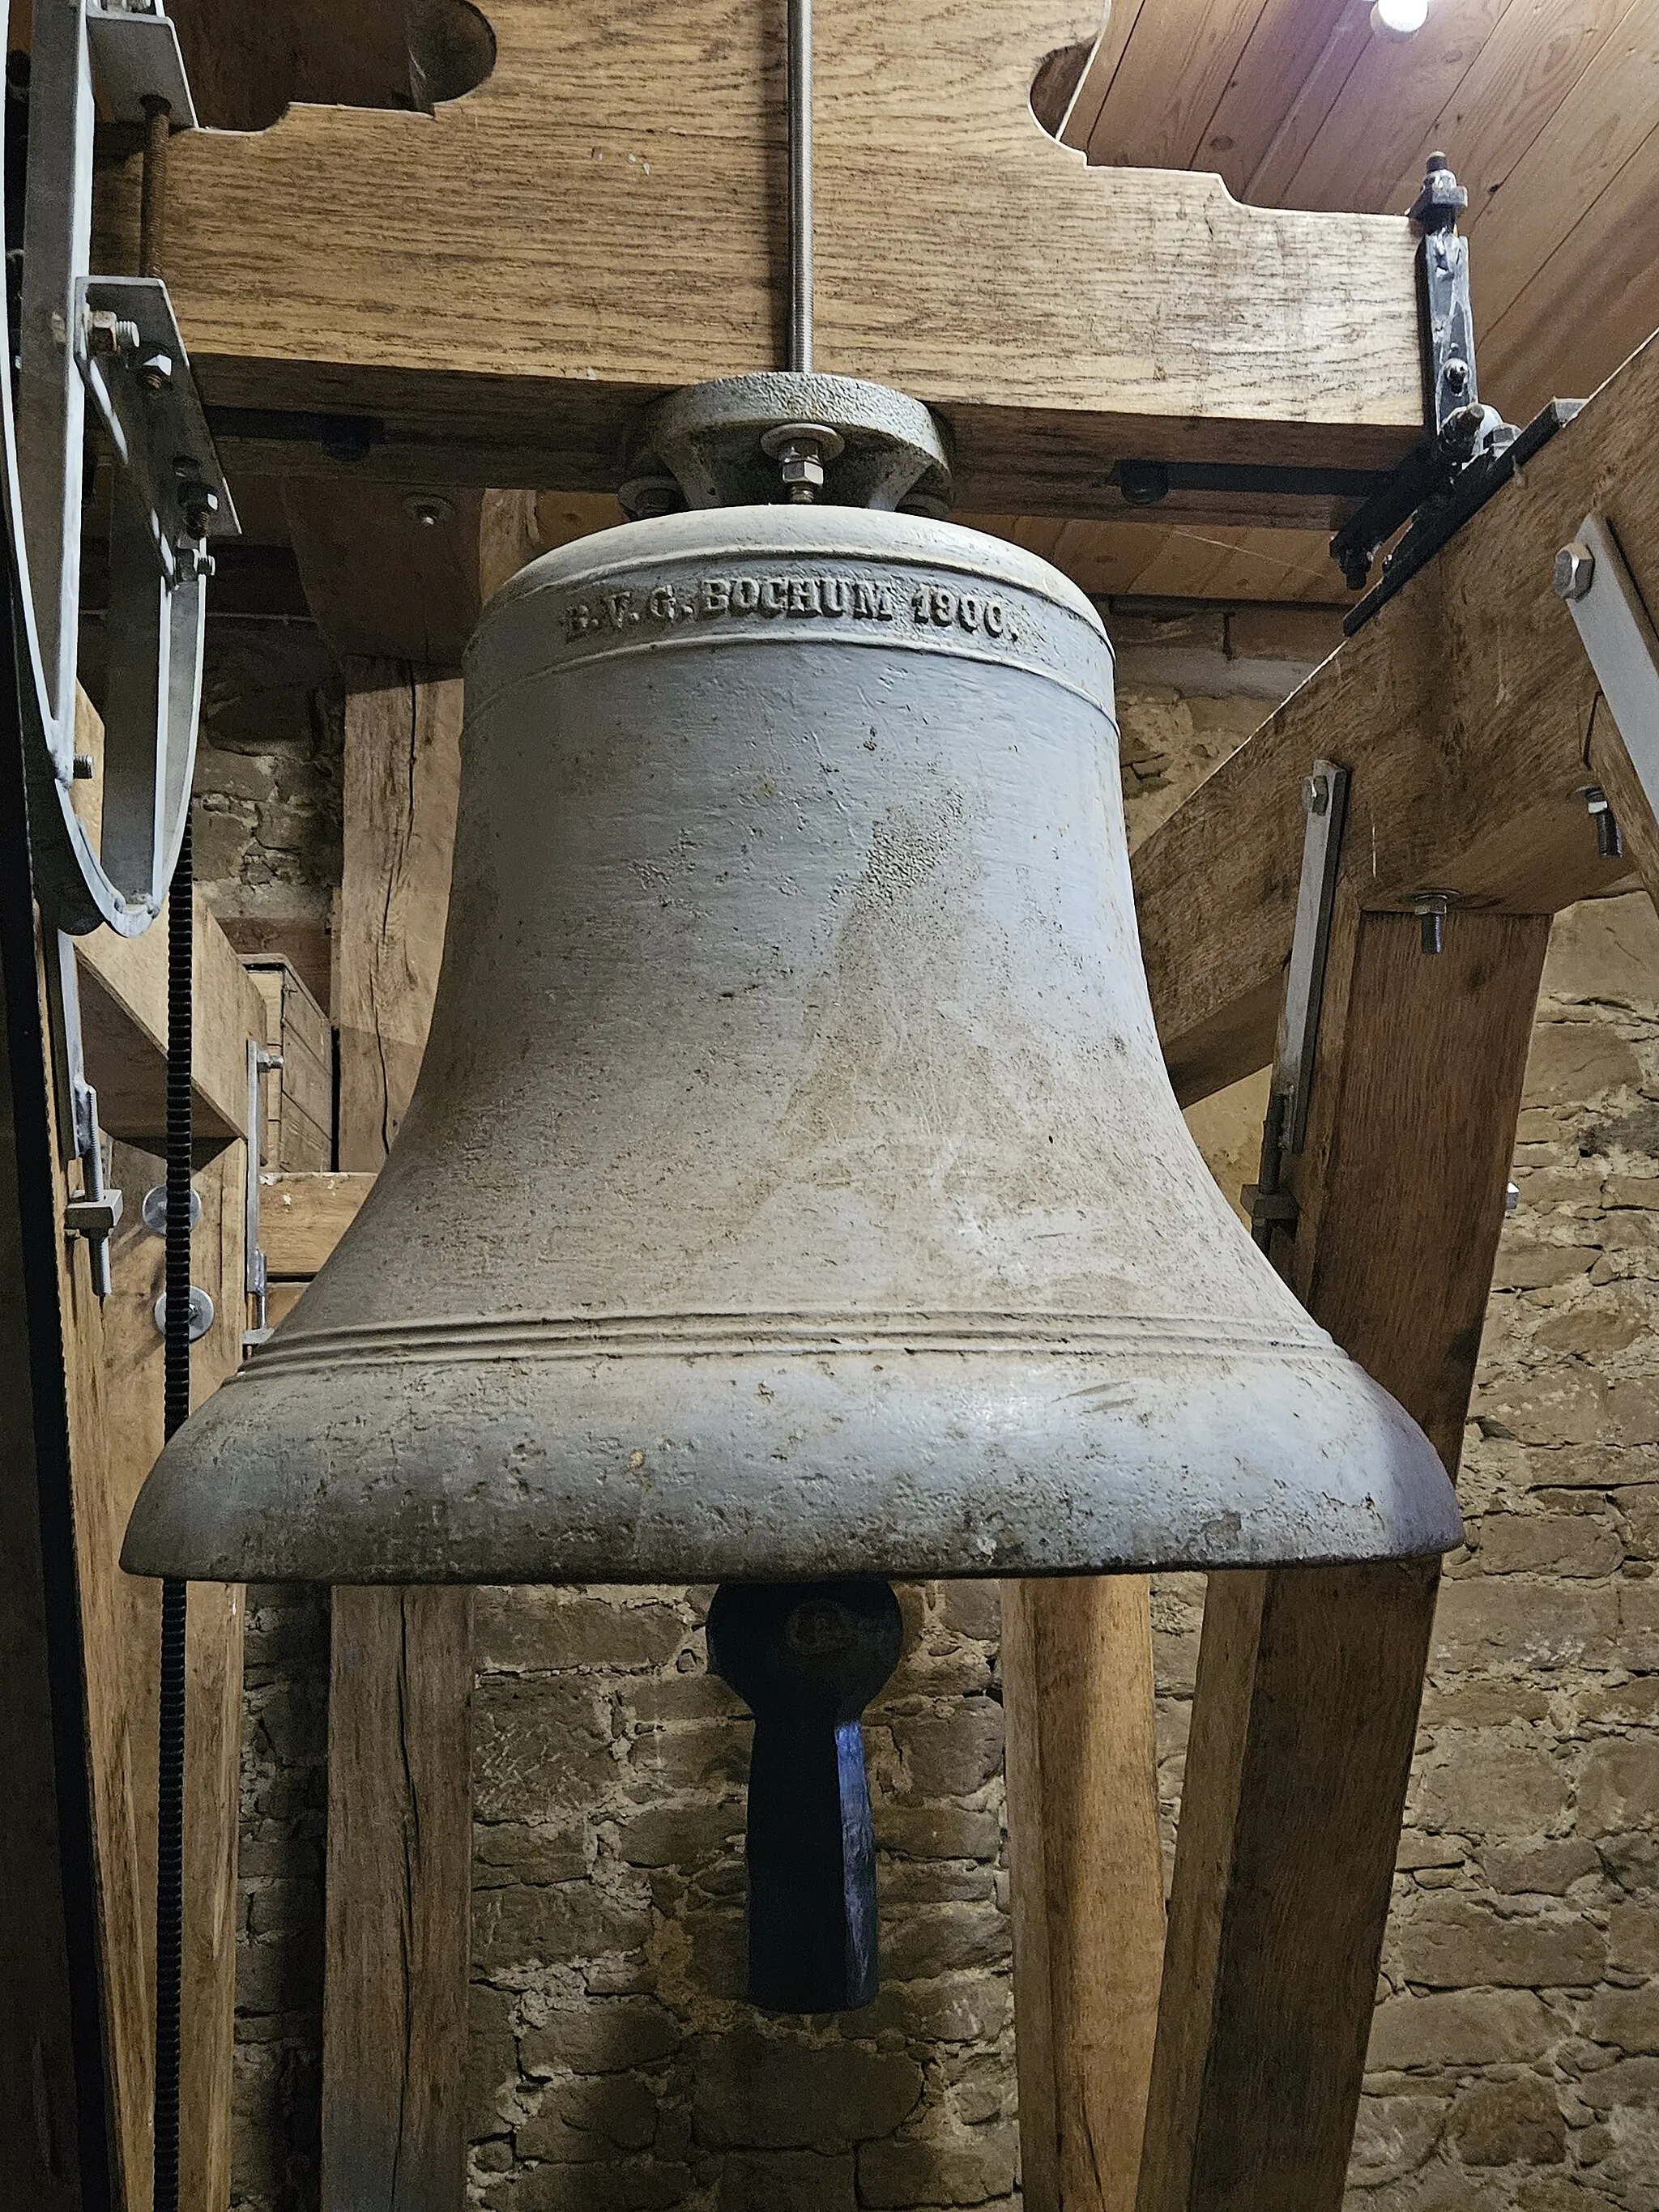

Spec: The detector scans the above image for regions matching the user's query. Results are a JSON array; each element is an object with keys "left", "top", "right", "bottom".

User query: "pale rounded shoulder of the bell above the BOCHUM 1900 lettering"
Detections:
[{"left": 480, "top": 505, "right": 1115, "bottom": 668}]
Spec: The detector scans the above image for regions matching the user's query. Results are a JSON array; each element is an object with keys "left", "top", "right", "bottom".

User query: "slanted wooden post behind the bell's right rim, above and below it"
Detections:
[{"left": 1137, "top": 902, "right": 1548, "bottom": 2212}]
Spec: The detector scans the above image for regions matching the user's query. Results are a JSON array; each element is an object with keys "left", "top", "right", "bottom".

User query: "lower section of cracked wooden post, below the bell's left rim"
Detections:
[{"left": 323, "top": 1588, "right": 473, "bottom": 2212}]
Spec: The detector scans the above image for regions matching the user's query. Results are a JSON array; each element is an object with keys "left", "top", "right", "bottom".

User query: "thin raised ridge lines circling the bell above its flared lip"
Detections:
[{"left": 243, "top": 1314, "right": 1336, "bottom": 1374}]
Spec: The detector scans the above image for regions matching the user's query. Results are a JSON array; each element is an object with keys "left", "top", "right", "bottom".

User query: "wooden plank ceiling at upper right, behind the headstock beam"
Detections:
[{"left": 996, "top": 0, "right": 1659, "bottom": 599}]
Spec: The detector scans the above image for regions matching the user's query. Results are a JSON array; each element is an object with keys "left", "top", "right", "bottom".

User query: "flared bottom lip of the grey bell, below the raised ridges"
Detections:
[{"left": 122, "top": 1347, "right": 1462, "bottom": 1583}]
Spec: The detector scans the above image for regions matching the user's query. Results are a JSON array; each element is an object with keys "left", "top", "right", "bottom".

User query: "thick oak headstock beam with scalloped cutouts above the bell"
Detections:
[{"left": 102, "top": 0, "right": 1422, "bottom": 514}]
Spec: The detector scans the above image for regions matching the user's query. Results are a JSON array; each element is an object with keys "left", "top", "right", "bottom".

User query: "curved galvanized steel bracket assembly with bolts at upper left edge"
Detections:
[{"left": 0, "top": 0, "right": 237, "bottom": 936}]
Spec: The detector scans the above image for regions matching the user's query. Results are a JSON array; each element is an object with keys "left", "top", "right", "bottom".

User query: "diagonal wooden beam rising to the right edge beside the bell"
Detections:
[{"left": 1132, "top": 316, "right": 1659, "bottom": 1102}]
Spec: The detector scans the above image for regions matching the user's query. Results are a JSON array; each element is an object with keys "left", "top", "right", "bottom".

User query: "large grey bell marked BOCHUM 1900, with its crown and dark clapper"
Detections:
[{"left": 124, "top": 378, "right": 1462, "bottom": 2010}]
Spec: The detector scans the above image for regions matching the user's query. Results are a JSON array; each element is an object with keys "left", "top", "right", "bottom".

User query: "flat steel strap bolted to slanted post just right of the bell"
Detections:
[{"left": 1239, "top": 761, "right": 1350, "bottom": 1252}]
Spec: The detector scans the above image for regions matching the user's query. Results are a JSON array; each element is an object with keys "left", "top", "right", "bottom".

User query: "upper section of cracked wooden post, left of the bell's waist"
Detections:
[{"left": 339, "top": 662, "right": 463, "bottom": 1170}]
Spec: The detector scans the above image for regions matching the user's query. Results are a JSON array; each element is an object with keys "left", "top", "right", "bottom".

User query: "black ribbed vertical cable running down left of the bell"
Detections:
[{"left": 155, "top": 814, "right": 194, "bottom": 2212}]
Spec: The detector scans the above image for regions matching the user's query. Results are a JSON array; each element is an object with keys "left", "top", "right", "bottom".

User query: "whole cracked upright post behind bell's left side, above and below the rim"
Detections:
[{"left": 323, "top": 662, "right": 471, "bottom": 2212}]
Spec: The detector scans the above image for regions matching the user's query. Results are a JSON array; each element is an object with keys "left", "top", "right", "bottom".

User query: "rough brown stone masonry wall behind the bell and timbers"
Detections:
[{"left": 201, "top": 611, "right": 1659, "bottom": 2212}]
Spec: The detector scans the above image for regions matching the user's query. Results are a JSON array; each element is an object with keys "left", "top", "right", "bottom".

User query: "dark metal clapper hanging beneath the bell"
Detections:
[{"left": 708, "top": 1575, "right": 902, "bottom": 2013}]
